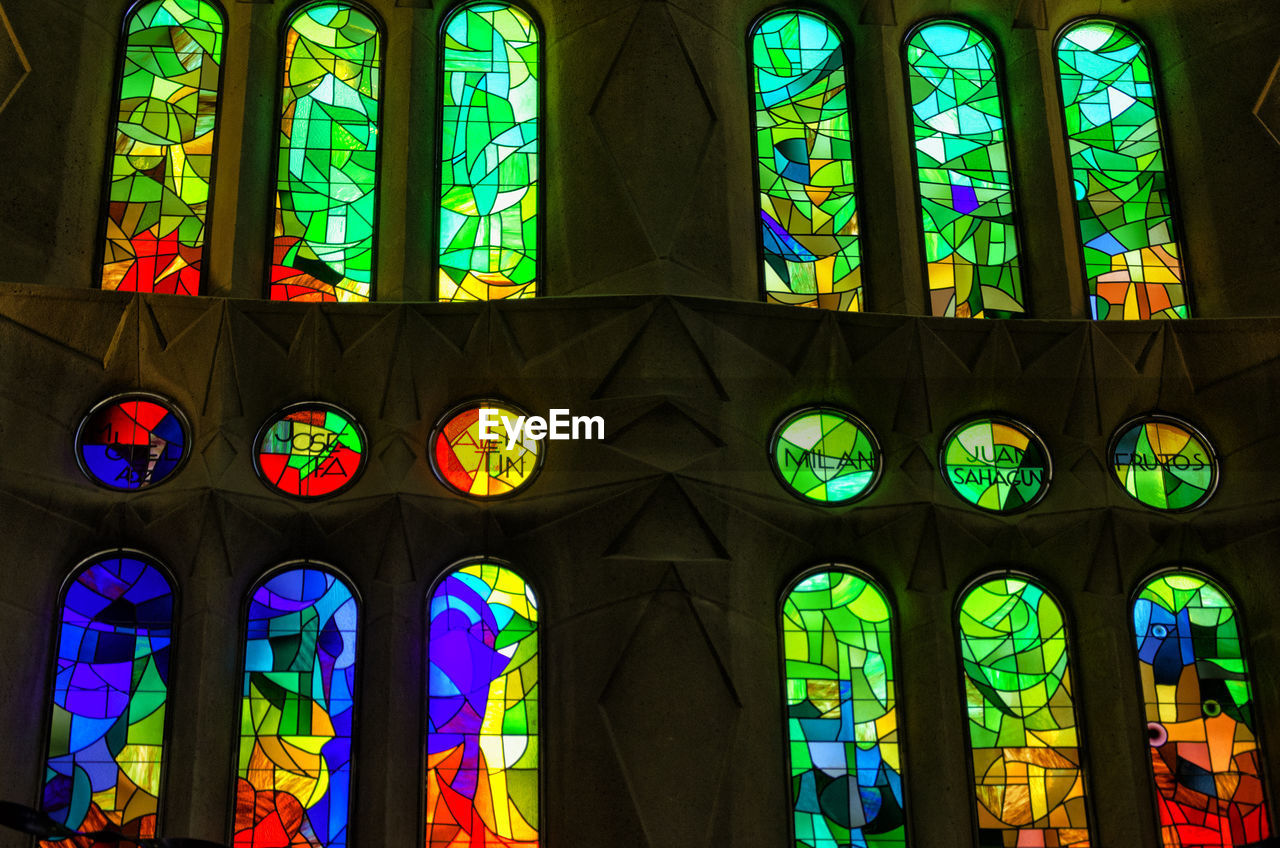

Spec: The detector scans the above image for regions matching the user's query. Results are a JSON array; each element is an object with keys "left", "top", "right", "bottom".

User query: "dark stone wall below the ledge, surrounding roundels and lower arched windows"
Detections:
[{"left": 0, "top": 286, "right": 1280, "bottom": 848}]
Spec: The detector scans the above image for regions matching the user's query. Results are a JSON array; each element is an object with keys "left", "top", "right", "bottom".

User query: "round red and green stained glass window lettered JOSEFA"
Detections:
[{"left": 253, "top": 401, "right": 369, "bottom": 498}]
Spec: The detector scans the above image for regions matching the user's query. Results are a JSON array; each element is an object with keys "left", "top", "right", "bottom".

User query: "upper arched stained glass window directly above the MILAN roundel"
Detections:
[{"left": 751, "top": 9, "right": 863, "bottom": 311}]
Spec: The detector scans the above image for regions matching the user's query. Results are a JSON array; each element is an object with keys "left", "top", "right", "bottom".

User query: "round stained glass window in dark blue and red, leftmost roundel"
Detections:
[{"left": 76, "top": 392, "right": 191, "bottom": 491}]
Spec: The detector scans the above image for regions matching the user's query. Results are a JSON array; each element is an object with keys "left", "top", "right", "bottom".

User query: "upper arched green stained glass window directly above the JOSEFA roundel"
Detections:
[{"left": 270, "top": 3, "right": 381, "bottom": 301}]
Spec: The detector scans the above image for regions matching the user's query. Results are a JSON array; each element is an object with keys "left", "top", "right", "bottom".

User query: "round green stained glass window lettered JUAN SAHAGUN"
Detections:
[{"left": 938, "top": 416, "right": 1053, "bottom": 512}]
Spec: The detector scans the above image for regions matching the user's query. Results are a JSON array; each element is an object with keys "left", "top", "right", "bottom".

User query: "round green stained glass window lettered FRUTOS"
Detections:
[{"left": 1107, "top": 415, "right": 1217, "bottom": 511}]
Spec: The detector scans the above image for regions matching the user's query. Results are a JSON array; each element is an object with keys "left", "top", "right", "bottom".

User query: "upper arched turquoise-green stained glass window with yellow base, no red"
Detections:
[{"left": 436, "top": 3, "right": 541, "bottom": 301}]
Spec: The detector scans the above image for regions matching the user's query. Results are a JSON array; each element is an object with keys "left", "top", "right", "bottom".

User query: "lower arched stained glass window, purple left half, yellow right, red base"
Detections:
[{"left": 425, "top": 560, "right": 540, "bottom": 848}]
